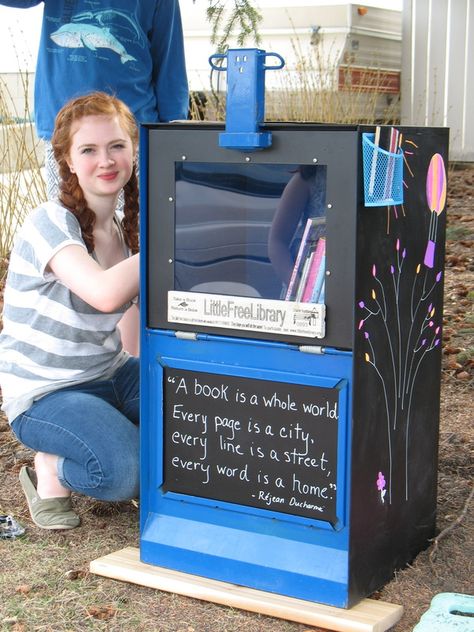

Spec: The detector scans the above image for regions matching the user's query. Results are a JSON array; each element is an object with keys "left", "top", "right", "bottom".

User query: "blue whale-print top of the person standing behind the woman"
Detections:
[{"left": 0, "top": 0, "right": 188, "bottom": 140}]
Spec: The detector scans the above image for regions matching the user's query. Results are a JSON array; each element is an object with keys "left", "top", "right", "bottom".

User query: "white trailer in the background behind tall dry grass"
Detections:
[{"left": 183, "top": 0, "right": 402, "bottom": 122}]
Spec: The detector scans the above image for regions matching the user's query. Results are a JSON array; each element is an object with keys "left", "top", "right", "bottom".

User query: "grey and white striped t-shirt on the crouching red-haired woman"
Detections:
[{"left": 0, "top": 202, "right": 130, "bottom": 422}]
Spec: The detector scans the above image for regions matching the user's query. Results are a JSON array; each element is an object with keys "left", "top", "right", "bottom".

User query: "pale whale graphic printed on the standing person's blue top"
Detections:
[{"left": 50, "top": 22, "right": 136, "bottom": 64}]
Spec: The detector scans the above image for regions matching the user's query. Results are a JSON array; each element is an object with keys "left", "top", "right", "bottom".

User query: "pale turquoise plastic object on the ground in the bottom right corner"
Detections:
[{"left": 413, "top": 593, "right": 474, "bottom": 632}]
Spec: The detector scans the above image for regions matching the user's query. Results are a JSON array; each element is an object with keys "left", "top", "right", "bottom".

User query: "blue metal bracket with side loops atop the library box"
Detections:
[{"left": 209, "top": 48, "right": 285, "bottom": 151}]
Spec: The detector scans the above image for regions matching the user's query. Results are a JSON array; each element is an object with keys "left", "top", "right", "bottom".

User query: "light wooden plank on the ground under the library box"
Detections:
[{"left": 90, "top": 547, "right": 403, "bottom": 632}]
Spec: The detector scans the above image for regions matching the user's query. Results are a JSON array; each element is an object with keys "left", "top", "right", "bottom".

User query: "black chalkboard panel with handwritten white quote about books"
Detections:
[{"left": 163, "top": 368, "right": 340, "bottom": 524}]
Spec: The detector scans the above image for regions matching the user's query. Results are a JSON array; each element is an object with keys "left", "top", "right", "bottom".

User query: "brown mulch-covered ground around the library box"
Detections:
[{"left": 0, "top": 165, "right": 474, "bottom": 632}]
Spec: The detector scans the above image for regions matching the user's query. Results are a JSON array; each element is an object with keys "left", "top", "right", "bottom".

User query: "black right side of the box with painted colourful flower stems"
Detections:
[{"left": 350, "top": 128, "right": 448, "bottom": 600}]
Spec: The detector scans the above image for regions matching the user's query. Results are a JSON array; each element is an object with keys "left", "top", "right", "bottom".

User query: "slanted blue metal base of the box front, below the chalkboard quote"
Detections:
[{"left": 140, "top": 514, "right": 348, "bottom": 608}]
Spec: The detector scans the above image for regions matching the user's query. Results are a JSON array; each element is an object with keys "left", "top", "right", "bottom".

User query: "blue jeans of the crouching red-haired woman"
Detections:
[{"left": 12, "top": 358, "right": 139, "bottom": 501}]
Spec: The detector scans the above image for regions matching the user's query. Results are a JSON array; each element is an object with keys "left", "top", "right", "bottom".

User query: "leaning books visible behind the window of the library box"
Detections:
[{"left": 285, "top": 217, "right": 326, "bottom": 303}]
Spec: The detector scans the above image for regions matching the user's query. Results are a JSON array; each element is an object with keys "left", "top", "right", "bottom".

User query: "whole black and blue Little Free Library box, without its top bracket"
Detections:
[{"left": 140, "top": 122, "right": 448, "bottom": 608}]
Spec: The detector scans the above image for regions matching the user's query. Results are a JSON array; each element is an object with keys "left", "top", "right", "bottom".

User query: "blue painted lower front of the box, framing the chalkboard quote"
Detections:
[{"left": 140, "top": 332, "right": 352, "bottom": 608}]
